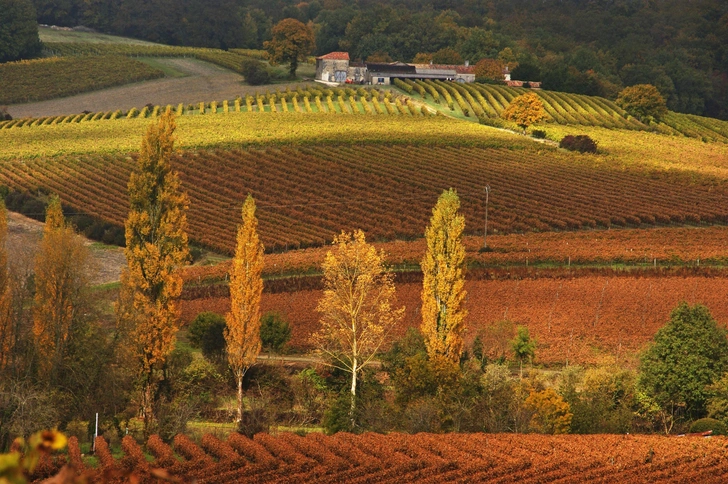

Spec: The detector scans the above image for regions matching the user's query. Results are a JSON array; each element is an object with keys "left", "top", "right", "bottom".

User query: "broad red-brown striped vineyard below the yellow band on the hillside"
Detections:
[{"left": 0, "top": 145, "right": 728, "bottom": 252}]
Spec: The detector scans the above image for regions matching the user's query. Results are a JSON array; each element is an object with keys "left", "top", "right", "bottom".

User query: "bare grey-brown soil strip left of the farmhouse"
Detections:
[{"left": 8, "top": 58, "right": 312, "bottom": 119}]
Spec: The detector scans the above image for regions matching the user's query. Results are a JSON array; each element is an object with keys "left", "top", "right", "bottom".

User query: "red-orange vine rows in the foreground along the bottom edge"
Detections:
[{"left": 36, "top": 433, "right": 728, "bottom": 484}]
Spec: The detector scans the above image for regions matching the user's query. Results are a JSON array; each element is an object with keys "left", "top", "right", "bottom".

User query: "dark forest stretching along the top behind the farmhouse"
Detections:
[{"left": 25, "top": 0, "right": 728, "bottom": 119}]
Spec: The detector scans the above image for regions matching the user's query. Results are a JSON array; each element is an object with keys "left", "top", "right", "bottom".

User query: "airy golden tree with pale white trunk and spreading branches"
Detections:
[{"left": 312, "top": 230, "right": 404, "bottom": 430}]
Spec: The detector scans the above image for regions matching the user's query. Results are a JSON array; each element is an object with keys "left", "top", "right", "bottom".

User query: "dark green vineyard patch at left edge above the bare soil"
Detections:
[{"left": 0, "top": 55, "right": 164, "bottom": 105}]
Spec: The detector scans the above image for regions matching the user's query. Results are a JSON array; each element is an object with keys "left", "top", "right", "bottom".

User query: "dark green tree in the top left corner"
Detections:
[{"left": 0, "top": 0, "right": 42, "bottom": 63}]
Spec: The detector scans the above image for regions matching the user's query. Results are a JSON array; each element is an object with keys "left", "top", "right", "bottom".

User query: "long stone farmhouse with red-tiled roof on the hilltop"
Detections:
[{"left": 316, "top": 52, "right": 475, "bottom": 85}]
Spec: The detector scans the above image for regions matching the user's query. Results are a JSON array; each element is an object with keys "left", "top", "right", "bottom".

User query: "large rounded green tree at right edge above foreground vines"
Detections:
[{"left": 638, "top": 302, "right": 728, "bottom": 424}]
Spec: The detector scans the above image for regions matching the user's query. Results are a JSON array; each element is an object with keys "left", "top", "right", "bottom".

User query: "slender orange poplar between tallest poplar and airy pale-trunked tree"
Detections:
[{"left": 225, "top": 195, "right": 263, "bottom": 422}]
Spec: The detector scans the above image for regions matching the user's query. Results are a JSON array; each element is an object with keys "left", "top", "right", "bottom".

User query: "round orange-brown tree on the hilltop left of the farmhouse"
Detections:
[{"left": 264, "top": 18, "right": 316, "bottom": 79}]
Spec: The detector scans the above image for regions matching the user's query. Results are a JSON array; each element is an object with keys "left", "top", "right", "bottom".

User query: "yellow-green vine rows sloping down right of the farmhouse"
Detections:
[{"left": 395, "top": 80, "right": 728, "bottom": 143}]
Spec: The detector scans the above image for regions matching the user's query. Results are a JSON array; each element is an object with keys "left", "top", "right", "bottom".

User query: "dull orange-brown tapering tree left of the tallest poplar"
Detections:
[{"left": 33, "top": 196, "right": 89, "bottom": 380}]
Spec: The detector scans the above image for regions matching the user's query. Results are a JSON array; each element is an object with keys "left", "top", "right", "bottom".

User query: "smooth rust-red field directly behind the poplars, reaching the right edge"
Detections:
[{"left": 180, "top": 275, "right": 728, "bottom": 365}]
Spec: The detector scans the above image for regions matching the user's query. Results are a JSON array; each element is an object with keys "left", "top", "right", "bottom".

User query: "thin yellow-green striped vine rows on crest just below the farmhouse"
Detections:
[{"left": 0, "top": 85, "right": 435, "bottom": 129}]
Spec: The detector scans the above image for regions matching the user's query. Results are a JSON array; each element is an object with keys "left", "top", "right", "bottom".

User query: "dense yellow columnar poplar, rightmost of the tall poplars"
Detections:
[{"left": 421, "top": 189, "right": 467, "bottom": 364}]
